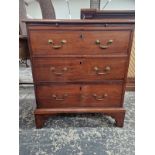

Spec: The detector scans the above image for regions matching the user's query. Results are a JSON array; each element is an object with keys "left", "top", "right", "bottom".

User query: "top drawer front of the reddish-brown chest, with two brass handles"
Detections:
[{"left": 29, "top": 30, "right": 130, "bottom": 55}]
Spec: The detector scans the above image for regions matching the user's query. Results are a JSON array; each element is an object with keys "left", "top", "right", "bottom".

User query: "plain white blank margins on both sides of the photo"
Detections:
[{"left": 0, "top": 0, "right": 155, "bottom": 155}]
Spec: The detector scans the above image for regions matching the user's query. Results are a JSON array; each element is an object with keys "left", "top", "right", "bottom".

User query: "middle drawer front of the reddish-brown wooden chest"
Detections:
[{"left": 33, "top": 58, "right": 127, "bottom": 82}]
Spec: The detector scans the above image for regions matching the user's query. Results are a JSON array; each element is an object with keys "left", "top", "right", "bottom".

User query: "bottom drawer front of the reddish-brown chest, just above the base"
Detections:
[{"left": 36, "top": 84, "right": 122, "bottom": 108}]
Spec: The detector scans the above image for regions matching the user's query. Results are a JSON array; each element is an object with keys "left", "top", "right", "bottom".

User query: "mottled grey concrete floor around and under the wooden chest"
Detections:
[{"left": 19, "top": 61, "right": 135, "bottom": 155}]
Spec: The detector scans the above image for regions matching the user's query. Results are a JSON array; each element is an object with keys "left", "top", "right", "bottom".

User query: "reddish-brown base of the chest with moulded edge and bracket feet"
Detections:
[{"left": 34, "top": 107, "right": 125, "bottom": 128}]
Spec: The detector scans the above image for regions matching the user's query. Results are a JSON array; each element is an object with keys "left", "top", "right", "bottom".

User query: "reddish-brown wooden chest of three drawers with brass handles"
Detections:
[{"left": 25, "top": 19, "right": 134, "bottom": 128}]
